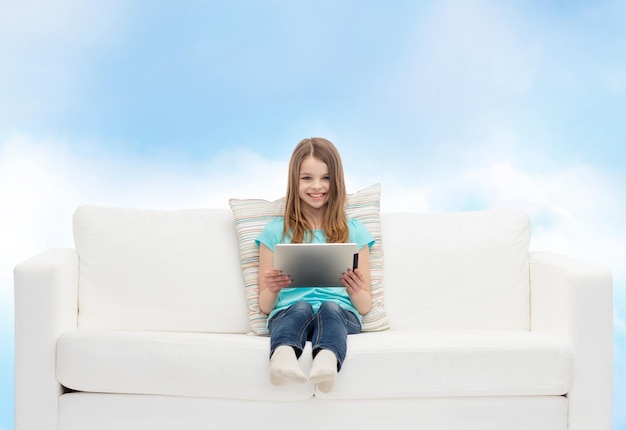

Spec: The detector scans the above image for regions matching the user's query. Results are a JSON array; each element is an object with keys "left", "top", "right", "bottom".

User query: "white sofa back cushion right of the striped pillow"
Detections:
[{"left": 381, "top": 211, "right": 530, "bottom": 330}]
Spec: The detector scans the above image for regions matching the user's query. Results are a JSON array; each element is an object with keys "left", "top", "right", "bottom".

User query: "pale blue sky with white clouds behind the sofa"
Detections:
[{"left": 0, "top": 0, "right": 626, "bottom": 430}]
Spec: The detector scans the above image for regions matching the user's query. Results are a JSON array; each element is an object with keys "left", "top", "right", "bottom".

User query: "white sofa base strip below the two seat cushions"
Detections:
[{"left": 58, "top": 393, "right": 568, "bottom": 430}]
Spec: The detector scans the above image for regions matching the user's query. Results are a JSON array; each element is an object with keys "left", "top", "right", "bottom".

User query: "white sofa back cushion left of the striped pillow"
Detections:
[{"left": 74, "top": 206, "right": 249, "bottom": 333}]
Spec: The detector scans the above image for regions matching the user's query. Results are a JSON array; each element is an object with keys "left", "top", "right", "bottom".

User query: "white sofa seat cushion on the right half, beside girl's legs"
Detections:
[{"left": 316, "top": 330, "right": 573, "bottom": 399}]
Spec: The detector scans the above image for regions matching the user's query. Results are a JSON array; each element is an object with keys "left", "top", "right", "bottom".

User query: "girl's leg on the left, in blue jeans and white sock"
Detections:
[{"left": 268, "top": 302, "right": 313, "bottom": 385}]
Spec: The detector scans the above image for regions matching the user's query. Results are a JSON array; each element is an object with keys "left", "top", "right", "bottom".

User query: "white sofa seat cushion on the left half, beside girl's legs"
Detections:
[{"left": 57, "top": 330, "right": 313, "bottom": 401}]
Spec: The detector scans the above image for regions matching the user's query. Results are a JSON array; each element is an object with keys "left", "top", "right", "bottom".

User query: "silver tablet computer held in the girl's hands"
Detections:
[{"left": 274, "top": 243, "right": 359, "bottom": 288}]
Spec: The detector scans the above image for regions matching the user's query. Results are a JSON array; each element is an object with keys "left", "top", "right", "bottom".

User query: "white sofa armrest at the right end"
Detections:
[{"left": 530, "top": 252, "right": 613, "bottom": 430}]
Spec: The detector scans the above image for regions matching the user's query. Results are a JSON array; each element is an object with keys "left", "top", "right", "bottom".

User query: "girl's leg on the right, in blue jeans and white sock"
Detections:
[{"left": 309, "top": 302, "right": 361, "bottom": 393}]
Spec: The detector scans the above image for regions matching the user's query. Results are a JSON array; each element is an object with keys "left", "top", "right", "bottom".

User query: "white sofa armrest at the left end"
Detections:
[{"left": 13, "top": 249, "right": 78, "bottom": 430}]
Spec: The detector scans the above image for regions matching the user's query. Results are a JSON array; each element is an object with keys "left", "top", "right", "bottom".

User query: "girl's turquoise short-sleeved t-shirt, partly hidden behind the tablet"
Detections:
[{"left": 256, "top": 217, "right": 374, "bottom": 321}]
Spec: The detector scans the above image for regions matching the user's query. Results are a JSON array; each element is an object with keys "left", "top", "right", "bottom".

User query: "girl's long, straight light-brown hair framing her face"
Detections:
[{"left": 283, "top": 137, "right": 349, "bottom": 243}]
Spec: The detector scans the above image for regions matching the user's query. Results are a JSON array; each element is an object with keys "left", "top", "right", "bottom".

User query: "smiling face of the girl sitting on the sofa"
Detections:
[{"left": 298, "top": 157, "right": 330, "bottom": 211}]
